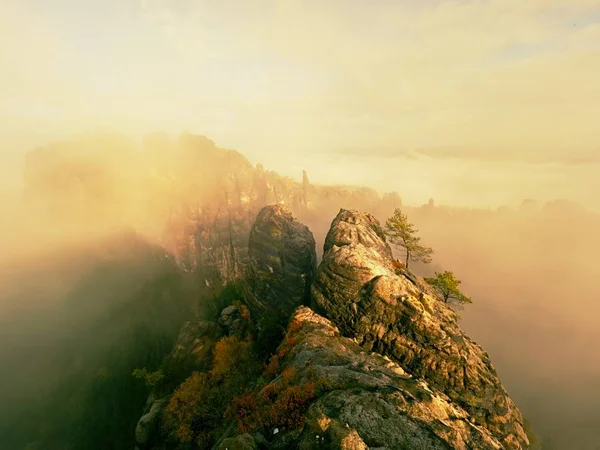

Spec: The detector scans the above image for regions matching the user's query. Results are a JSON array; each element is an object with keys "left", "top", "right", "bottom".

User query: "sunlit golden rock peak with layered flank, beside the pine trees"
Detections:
[{"left": 312, "top": 210, "right": 528, "bottom": 449}]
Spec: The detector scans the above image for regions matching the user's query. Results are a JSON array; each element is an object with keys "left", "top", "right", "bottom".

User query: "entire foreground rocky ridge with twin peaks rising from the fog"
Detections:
[{"left": 136, "top": 205, "right": 529, "bottom": 450}]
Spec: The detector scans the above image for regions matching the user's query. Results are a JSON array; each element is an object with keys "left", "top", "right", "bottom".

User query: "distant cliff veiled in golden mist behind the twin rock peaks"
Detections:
[{"left": 19, "top": 133, "right": 399, "bottom": 282}]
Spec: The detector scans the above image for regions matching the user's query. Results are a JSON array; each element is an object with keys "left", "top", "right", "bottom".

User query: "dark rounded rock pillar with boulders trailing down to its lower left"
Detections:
[{"left": 136, "top": 205, "right": 316, "bottom": 449}]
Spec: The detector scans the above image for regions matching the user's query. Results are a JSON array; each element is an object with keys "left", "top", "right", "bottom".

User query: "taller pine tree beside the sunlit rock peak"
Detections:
[{"left": 385, "top": 208, "right": 433, "bottom": 269}]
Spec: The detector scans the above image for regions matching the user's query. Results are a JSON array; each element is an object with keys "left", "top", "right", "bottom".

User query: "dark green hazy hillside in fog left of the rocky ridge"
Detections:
[{"left": 0, "top": 233, "right": 198, "bottom": 449}]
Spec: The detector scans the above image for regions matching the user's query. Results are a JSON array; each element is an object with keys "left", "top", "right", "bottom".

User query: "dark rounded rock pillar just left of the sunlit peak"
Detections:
[{"left": 246, "top": 205, "right": 317, "bottom": 324}]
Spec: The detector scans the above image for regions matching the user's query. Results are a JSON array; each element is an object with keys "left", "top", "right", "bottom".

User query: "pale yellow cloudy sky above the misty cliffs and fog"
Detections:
[{"left": 0, "top": 0, "right": 600, "bottom": 209}]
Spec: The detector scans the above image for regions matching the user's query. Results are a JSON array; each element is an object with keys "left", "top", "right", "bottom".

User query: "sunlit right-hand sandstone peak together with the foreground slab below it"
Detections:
[{"left": 215, "top": 210, "right": 529, "bottom": 450}]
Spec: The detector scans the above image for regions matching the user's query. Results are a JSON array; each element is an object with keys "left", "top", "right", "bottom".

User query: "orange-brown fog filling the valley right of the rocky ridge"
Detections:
[{"left": 406, "top": 204, "right": 600, "bottom": 449}]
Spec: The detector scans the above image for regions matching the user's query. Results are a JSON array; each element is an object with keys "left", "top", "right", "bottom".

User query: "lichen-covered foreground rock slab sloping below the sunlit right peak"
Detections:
[{"left": 229, "top": 306, "right": 506, "bottom": 450}]
